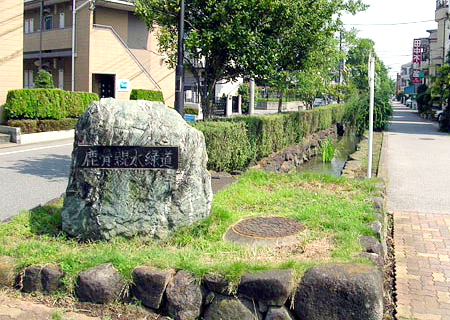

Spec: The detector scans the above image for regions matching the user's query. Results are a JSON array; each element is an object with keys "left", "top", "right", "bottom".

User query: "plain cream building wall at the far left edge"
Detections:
[{"left": 0, "top": 0, "right": 23, "bottom": 123}]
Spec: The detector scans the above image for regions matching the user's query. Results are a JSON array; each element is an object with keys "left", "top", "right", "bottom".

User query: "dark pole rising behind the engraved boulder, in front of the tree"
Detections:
[{"left": 175, "top": 0, "right": 184, "bottom": 116}]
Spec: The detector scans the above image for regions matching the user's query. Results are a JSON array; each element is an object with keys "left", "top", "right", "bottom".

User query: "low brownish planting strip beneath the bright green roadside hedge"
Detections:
[{"left": 6, "top": 118, "right": 78, "bottom": 133}]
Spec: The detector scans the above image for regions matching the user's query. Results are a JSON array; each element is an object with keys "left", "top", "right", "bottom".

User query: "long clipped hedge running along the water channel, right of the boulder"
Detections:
[{"left": 194, "top": 105, "right": 346, "bottom": 171}]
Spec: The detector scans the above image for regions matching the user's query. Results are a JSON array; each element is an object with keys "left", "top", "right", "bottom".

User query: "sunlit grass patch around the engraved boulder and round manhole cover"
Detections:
[{"left": 0, "top": 170, "right": 379, "bottom": 290}]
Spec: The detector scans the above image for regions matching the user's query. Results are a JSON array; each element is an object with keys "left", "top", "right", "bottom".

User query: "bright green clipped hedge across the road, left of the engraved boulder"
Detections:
[{"left": 5, "top": 89, "right": 99, "bottom": 120}]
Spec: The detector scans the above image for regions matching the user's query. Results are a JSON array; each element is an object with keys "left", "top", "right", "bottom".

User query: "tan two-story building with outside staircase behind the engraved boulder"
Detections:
[{"left": 23, "top": 0, "right": 175, "bottom": 106}]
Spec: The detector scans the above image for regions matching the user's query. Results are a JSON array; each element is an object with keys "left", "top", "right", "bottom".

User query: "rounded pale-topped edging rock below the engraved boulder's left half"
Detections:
[{"left": 75, "top": 263, "right": 124, "bottom": 303}]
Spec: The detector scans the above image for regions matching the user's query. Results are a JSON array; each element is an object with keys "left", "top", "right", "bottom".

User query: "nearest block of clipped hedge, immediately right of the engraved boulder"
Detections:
[{"left": 192, "top": 121, "right": 251, "bottom": 171}]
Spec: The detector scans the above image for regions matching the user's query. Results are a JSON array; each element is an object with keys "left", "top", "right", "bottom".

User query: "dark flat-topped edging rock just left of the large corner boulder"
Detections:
[{"left": 238, "top": 269, "right": 293, "bottom": 306}]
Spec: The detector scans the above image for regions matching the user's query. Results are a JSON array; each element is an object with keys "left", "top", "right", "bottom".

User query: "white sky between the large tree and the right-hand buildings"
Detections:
[{"left": 342, "top": 0, "right": 437, "bottom": 79}]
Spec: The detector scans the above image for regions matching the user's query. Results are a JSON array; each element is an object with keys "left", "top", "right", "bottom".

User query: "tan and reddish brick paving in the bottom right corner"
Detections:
[{"left": 394, "top": 212, "right": 450, "bottom": 320}]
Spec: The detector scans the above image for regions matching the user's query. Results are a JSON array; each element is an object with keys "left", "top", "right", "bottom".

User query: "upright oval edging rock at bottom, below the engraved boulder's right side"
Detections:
[{"left": 166, "top": 270, "right": 203, "bottom": 320}]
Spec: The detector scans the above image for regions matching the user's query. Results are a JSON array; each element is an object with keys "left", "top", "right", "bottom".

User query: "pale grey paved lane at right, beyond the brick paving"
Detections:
[{"left": 383, "top": 103, "right": 450, "bottom": 214}]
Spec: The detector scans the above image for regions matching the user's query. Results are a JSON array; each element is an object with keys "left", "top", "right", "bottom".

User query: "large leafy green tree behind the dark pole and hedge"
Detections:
[{"left": 136, "top": 0, "right": 363, "bottom": 117}]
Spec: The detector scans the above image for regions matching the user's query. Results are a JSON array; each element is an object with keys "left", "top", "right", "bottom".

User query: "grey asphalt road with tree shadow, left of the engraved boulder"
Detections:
[{"left": 0, "top": 139, "right": 73, "bottom": 221}]
